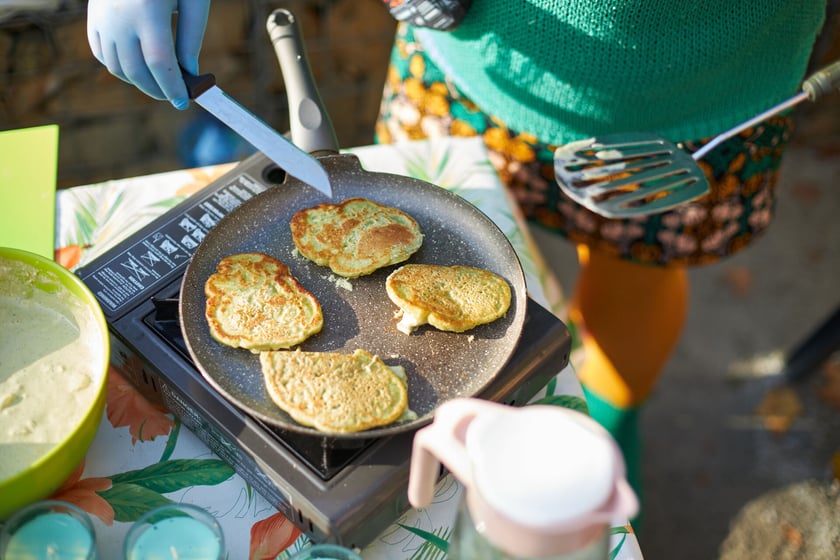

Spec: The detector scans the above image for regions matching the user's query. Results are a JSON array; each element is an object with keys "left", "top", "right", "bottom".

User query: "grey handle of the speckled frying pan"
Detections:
[{"left": 266, "top": 8, "right": 338, "bottom": 153}]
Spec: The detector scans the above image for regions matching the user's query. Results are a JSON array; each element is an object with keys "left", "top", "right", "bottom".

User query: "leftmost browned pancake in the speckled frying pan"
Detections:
[{"left": 204, "top": 253, "right": 324, "bottom": 352}]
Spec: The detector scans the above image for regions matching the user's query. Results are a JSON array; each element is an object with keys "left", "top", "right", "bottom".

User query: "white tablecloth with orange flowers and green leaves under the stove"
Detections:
[{"left": 44, "top": 139, "right": 641, "bottom": 560}]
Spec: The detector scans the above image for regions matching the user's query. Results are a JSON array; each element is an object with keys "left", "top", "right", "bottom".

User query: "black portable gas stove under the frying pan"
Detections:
[{"left": 78, "top": 153, "right": 571, "bottom": 547}]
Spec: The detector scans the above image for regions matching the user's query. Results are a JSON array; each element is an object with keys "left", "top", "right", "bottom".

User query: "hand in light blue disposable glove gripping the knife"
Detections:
[{"left": 87, "top": 0, "right": 210, "bottom": 109}]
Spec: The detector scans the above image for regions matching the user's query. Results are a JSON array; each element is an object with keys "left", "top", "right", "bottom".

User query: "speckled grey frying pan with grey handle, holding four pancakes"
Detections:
[{"left": 180, "top": 6, "right": 527, "bottom": 439}]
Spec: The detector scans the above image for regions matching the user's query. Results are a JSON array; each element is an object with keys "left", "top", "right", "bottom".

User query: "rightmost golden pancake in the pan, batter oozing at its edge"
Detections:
[{"left": 385, "top": 264, "right": 511, "bottom": 334}]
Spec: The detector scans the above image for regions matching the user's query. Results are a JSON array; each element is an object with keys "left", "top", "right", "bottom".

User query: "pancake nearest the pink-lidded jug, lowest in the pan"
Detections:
[{"left": 260, "top": 349, "right": 408, "bottom": 433}]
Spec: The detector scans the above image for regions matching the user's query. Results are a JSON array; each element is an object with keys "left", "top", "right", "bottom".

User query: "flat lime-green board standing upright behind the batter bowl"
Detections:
[{"left": 0, "top": 125, "right": 58, "bottom": 259}]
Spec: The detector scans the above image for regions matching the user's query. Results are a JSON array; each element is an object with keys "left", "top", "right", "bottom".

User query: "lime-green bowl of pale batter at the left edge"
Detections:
[{"left": 0, "top": 247, "right": 110, "bottom": 520}]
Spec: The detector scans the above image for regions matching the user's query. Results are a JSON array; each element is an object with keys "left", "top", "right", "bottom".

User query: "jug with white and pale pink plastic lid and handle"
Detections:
[{"left": 408, "top": 399, "right": 638, "bottom": 560}]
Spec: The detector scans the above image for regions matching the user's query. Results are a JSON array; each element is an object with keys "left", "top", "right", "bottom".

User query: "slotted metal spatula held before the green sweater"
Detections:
[{"left": 554, "top": 61, "right": 840, "bottom": 218}]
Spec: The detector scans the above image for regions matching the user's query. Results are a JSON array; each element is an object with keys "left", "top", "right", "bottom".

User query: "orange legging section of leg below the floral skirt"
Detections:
[{"left": 569, "top": 245, "right": 688, "bottom": 408}]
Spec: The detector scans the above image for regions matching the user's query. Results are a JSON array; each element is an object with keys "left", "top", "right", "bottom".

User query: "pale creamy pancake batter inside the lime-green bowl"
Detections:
[{"left": 0, "top": 258, "right": 102, "bottom": 481}]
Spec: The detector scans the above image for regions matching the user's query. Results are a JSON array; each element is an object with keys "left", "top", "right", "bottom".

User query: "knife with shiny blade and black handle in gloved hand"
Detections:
[{"left": 181, "top": 68, "right": 332, "bottom": 197}]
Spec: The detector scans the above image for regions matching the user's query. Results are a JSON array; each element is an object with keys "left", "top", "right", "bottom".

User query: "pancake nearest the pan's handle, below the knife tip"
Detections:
[{"left": 289, "top": 198, "right": 423, "bottom": 278}]
